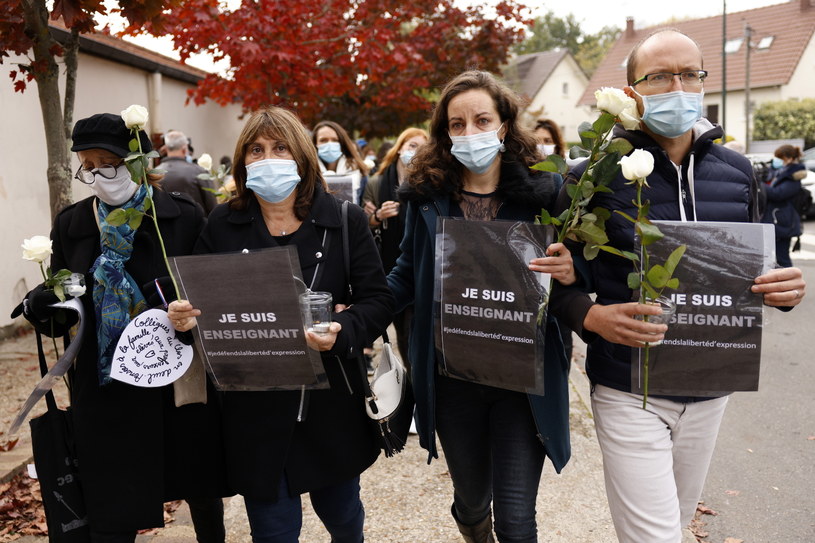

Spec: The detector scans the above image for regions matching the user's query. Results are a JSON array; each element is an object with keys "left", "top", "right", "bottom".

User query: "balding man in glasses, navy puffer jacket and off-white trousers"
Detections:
[{"left": 558, "top": 29, "right": 805, "bottom": 543}]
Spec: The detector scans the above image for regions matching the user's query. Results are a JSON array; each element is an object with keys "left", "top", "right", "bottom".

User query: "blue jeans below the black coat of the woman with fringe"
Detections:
[{"left": 243, "top": 475, "right": 365, "bottom": 543}]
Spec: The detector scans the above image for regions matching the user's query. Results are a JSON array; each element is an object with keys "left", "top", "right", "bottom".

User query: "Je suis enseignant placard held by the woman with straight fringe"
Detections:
[{"left": 171, "top": 246, "right": 328, "bottom": 390}]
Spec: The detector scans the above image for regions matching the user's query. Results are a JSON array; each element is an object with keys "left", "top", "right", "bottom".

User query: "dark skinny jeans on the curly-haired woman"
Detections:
[{"left": 436, "top": 375, "right": 546, "bottom": 543}]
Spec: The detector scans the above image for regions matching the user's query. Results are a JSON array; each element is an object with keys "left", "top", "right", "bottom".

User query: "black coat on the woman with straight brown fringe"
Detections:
[{"left": 195, "top": 189, "right": 393, "bottom": 500}]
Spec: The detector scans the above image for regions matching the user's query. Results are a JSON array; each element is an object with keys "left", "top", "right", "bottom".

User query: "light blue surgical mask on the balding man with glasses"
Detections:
[{"left": 637, "top": 91, "right": 704, "bottom": 138}]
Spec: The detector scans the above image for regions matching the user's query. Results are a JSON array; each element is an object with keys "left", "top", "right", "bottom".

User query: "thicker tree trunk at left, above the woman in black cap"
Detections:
[{"left": 23, "top": 0, "right": 76, "bottom": 219}]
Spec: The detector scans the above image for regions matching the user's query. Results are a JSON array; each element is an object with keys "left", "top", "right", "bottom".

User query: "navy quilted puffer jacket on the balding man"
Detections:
[{"left": 558, "top": 119, "right": 758, "bottom": 398}]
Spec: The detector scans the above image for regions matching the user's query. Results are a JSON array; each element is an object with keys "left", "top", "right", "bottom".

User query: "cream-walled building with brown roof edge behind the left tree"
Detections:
[{"left": 0, "top": 26, "right": 249, "bottom": 337}]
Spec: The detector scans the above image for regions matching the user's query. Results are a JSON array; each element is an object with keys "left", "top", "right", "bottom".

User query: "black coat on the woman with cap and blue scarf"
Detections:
[{"left": 51, "top": 190, "right": 223, "bottom": 531}]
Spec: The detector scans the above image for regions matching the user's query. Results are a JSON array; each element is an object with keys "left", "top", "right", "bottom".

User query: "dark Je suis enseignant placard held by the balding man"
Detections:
[{"left": 631, "top": 221, "right": 774, "bottom": 396}]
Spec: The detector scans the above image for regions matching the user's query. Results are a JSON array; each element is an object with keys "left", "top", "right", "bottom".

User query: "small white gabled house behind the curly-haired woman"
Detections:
[{"left": 504, "top": 49, "right": 591, "bottom": 141}]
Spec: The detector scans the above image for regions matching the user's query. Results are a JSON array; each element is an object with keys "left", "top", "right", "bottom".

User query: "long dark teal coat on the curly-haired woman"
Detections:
[{"left": 388, "top": 156, "right": 571, "bottom": 472}]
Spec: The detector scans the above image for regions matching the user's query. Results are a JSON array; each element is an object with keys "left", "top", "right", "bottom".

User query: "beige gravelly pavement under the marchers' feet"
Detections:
[{"left": 0, "top": 334, "right": 616, "bottom": 543}]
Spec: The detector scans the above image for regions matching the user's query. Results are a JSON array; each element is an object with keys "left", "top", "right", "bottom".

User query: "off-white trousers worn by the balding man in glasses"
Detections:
[{"left": 592, "top": 385, "right": 727, "bottom": 543}]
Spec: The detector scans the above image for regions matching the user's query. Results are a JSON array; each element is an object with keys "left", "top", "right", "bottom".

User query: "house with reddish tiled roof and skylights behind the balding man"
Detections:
[{"left": 580, "top": 0, "right": 815, "bottom": 151}]
